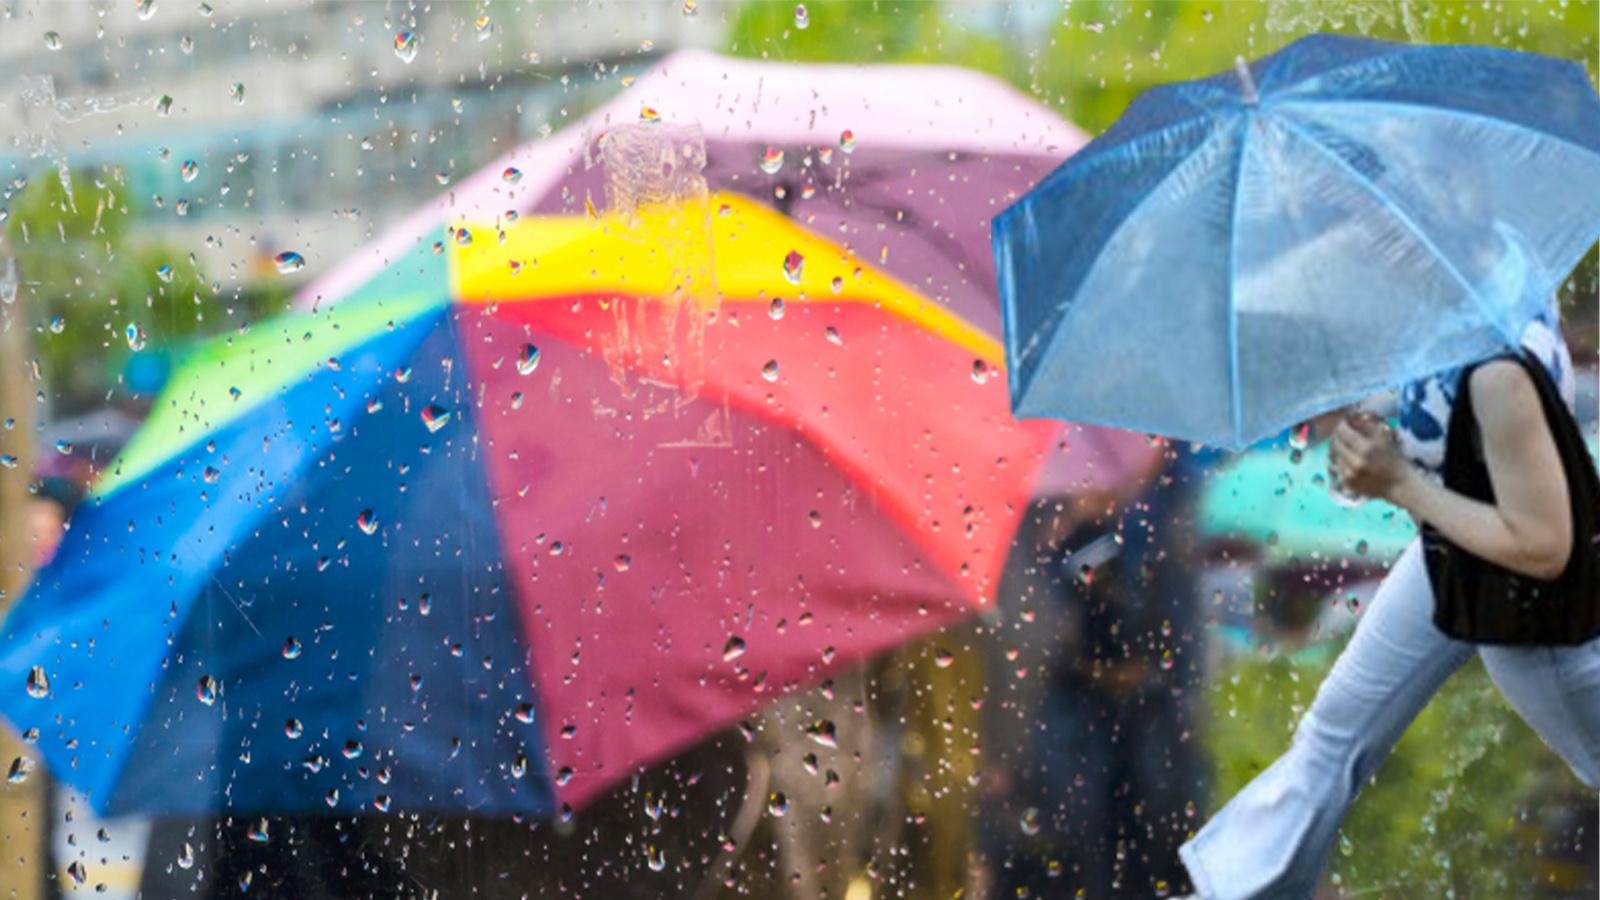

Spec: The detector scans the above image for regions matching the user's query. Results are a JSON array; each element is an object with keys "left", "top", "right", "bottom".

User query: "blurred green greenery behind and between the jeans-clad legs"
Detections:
[{"left": 1203, "top": 647, "right": 1594, "bottom": 900}]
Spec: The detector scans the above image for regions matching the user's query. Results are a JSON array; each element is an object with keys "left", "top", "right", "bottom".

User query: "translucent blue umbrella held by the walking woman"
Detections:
[{"left": 994, "top": 35, "right": 1600, "bottom": 447}]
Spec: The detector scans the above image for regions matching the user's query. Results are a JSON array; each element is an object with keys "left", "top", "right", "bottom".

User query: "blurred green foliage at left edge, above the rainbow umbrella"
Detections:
[{"left": 5, "top": 168, "right": 285, "bottom": 416}]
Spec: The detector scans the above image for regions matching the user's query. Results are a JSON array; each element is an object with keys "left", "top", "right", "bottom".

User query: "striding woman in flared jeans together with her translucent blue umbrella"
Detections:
[{"left": 995, "top": 35, "right": 1600, "bottom": 900}]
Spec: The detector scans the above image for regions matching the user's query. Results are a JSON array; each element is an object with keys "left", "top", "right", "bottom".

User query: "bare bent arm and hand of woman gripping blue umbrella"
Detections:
[{"left": 1331, "top": 360, "right": 1573, "bottom": 578}]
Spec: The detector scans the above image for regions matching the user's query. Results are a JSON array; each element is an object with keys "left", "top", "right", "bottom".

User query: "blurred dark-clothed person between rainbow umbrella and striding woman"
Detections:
[{"left": 984, "top": 448, "right": 1205, "bottom": 900}]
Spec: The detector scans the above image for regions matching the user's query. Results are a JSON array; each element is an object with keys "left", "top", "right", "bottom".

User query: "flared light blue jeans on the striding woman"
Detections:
[{"left": 1179, "top": 543, "right": 1600, "bottom": 900}]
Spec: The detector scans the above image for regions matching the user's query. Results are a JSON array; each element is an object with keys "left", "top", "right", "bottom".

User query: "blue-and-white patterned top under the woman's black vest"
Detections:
[{"left": 1398, "top": 303, "right": 1576, "bottom": 477}]
